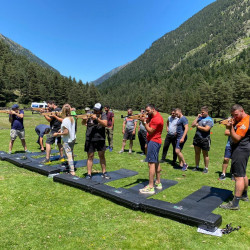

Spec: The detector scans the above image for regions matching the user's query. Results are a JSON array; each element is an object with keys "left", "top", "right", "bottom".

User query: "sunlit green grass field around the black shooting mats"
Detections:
[{"left": 0, "top": 112, "right": 250, "bottom": 249}]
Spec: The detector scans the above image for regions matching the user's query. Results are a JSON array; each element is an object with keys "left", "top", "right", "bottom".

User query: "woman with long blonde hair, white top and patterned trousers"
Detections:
[{"left": 53, "top": 104, "right": 76, "bottom": 175}]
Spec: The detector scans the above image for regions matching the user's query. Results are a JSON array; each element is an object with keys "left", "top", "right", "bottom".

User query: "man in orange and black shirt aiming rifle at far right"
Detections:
[{"left": 220, "top": 104, "right": 250, "bottom": 210}]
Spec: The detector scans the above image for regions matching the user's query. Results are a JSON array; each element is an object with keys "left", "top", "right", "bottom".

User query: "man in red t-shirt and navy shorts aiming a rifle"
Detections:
[{"left": 140, "top": 104, "right": 164, "bottom": 194}]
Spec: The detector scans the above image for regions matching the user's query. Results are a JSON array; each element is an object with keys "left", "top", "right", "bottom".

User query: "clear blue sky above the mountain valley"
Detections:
[{"left": 0, "top": 0, "right": 214, "bottom": 82}]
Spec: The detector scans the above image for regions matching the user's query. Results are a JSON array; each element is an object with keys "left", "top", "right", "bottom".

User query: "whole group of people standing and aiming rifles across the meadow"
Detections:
[{"left": 4, "top": 101, "right": 250, "bottom": 210}]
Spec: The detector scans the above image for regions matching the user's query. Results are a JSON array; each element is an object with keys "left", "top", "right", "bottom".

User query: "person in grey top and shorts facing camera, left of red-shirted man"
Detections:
[{"left": 119, "top": 109, "right": 137, "bottom": 154}]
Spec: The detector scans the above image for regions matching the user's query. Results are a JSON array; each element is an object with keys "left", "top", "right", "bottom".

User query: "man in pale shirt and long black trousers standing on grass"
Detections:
[{"left": 160, "top": 109, "right": 179, "bottom": 165}]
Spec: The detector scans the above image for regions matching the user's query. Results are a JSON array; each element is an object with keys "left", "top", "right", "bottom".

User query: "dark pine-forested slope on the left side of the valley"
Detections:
[{"left": 0, "top": 40, "right": 100, "bottom": 108}]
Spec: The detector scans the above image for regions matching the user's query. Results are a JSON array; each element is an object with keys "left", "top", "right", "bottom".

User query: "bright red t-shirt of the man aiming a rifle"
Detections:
[{"left": 147, "top": 112, "right": 164, "bottom": 144}]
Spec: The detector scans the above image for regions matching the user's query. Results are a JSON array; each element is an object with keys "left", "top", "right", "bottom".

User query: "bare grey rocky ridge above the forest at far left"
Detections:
[{"left": 0, "top": 34, "right": 58, "bottom": 72}]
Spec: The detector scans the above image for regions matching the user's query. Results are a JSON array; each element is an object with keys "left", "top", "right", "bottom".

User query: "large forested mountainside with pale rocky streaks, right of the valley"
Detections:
[{"left": 98, "top": 0, "right": 250, "bottom": 116}]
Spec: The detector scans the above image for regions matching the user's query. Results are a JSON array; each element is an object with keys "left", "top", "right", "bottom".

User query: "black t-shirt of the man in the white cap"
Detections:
[{"left": 86, "top": 113, "right": 107, "bottom": 141}]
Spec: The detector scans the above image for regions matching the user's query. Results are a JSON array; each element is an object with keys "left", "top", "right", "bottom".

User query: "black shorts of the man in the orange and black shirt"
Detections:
[{"left": 231, "top": 148, "right": 250, "bottom": 177}]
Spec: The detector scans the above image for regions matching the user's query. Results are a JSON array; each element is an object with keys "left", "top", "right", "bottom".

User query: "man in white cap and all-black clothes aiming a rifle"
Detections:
[{"left": 85, "top": 103, "right": 110, "bottom": 179}]
